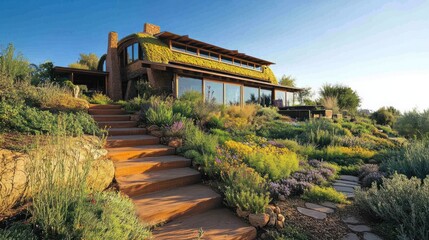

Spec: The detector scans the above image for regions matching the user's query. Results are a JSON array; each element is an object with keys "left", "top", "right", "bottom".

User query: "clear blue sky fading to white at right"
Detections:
[{"left": 0, "top": 0, "right": 429, "bottom": 110}]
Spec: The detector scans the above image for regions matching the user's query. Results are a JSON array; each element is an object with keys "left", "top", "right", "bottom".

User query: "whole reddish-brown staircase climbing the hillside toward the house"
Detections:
[{"left": 89, "top": 105, "right": 256, "bottom": 240}]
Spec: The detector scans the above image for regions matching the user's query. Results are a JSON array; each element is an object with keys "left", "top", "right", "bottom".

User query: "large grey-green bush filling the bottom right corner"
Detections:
[{"left": 355, "top": 174, "right": 429, "bottom": 239}]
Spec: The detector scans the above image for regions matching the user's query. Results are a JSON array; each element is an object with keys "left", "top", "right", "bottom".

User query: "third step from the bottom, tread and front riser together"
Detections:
[{"left": 116, "top": 168, "right": 201, "bottom": 196}]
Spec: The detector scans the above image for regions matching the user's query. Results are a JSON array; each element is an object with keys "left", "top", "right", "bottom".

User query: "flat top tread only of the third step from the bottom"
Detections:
[{"left": 116, "top": 167, "right": 200, "bottom": 188}]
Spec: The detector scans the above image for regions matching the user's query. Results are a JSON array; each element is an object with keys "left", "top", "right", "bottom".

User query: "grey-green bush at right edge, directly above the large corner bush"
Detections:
[{"left": 382, "top": 138, "right": 429, "bottom": 179}]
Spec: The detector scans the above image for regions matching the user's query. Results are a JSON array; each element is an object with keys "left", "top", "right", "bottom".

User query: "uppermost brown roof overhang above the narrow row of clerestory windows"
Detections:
[{"left": 155, "top": 32, "right": 274, "bottom": 66}]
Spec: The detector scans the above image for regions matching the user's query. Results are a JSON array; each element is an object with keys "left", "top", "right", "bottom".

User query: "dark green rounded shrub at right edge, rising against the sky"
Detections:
[{"left": 394, "top": 109, "right": 429, "bottom": 138}]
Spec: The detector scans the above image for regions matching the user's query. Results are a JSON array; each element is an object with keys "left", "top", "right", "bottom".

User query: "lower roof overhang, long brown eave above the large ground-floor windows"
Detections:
[{"left": 142, "top": 61, "right": 303, "bottom": 92}]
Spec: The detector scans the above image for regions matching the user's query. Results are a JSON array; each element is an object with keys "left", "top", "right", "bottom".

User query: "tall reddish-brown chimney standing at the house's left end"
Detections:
[{"left": 106, "top": 32, "right": 122, "bottom": 101}]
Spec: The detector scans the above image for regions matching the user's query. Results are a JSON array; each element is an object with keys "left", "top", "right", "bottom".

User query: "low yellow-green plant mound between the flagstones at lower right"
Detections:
[{"left": 302, "top": 186, "right": 347, "bottom": 203}]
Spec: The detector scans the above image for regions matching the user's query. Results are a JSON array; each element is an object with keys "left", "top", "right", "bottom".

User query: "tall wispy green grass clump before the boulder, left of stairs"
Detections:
[{"left": 23, "top": 126, "right": 150, "bottom": 239}]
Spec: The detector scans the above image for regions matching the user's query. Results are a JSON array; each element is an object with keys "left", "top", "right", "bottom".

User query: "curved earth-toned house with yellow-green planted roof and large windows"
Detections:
[{"left": 99, "top": 23, "right": 300, "bottom": 107}]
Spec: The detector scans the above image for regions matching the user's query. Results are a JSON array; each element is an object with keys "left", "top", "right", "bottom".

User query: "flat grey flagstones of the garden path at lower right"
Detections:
[{"left": 297, "top": 175, "right": 382, "bottom": 240}]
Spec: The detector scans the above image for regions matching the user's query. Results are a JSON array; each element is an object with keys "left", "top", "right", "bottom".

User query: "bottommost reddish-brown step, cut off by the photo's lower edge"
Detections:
[{"left": 153, "top": 209, "right": 256, "bottom": 240}]
